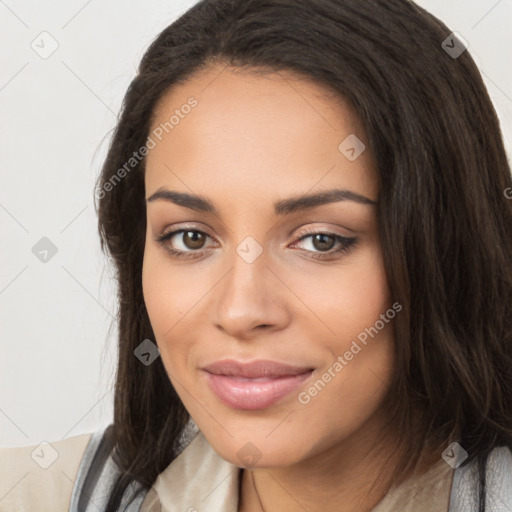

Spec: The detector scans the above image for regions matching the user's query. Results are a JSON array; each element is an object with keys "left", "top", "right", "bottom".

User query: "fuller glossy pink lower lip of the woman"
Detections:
[{"left": 206, "top": 371, "right": 312, "bottom": 410}]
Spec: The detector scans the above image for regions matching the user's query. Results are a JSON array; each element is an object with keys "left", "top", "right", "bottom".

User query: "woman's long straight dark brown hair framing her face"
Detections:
[{"left": 97, "top": 0, "right": 512, "bottom": 512}]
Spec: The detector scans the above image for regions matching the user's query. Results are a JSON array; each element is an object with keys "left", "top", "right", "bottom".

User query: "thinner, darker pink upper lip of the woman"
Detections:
[{"left": 203, "top": 359, "right": 313, "bottom": 379}]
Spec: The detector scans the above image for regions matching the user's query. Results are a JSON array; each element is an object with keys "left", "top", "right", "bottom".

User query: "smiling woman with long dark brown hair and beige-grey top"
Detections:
[{"left": 0, "top": 0, "right": 512, "bottom": 512}]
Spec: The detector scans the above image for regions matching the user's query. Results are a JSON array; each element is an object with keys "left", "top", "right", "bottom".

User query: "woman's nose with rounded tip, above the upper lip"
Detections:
[{"left": 216, "top": 247, "right": 290, "bottom": 340}]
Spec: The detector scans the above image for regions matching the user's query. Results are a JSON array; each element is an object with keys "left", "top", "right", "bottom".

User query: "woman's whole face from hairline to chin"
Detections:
[{"left": 143, "top": 67, "right": 400, "bottom": 467}]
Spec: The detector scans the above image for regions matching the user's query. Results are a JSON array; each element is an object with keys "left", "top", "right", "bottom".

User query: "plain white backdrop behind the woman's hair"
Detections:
[{"left": 0, "top": 0, "right": 512, "bottom": 446}]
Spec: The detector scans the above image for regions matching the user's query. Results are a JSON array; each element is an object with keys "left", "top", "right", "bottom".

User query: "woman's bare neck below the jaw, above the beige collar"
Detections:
[{"left": 238, "top": 410, "right": 431, "bottom": 512}]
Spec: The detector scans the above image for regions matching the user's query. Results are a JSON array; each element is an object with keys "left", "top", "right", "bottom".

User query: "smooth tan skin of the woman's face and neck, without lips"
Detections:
[{"left": 143, "top": 65, "right": 398, "bottom": 512}]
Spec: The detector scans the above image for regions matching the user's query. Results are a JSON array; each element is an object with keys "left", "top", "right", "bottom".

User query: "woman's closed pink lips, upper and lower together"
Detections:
[{"left": 203, "top": 359, "right": 313, "bottom": 410}]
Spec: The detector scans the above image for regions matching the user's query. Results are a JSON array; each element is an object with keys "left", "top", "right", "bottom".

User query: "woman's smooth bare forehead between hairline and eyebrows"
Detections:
[{"left": 145, "top": 65, "right": 377, "bottom": 205}]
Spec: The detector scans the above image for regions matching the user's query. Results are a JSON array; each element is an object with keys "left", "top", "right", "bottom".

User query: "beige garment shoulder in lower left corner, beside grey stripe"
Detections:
[{"left": 0, "top": 428, "right": 105, "bottom": 512}]
